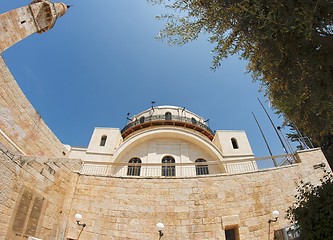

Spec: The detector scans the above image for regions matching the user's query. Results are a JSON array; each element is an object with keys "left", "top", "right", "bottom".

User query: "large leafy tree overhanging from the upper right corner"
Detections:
[{"left": 147, "top": 0, "right": 333, "bottom": 165}]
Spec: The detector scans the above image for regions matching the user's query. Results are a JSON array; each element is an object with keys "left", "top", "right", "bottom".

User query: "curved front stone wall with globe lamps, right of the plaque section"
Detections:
[{"left": 67, "top": 149, "right": 329, "bottom": 240}]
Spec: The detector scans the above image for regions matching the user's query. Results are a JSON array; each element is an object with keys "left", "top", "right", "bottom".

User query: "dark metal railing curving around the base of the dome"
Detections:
[{"left": 121, "top": 115, "right": 214, "bottom": 135}]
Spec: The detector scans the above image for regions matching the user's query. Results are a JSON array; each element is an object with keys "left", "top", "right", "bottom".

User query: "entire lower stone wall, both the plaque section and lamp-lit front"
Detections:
[{"left": 0, "top": 140, "right": 330, "bottom": 240}]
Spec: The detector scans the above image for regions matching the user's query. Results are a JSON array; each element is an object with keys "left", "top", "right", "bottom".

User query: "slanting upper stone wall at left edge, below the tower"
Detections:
[{"left": 0, "top": 56, "right": 67, "bottom": 157}]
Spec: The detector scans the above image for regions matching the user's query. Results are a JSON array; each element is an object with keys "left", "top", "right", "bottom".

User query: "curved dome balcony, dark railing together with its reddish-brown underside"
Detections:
[{"left": 121, "top": 115, "right": 215, "bottom": 140}]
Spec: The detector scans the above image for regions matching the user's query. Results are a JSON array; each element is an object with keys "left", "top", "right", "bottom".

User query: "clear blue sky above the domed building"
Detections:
[{"left": 0, "top": 0, "right": 294, "bottom": 164}]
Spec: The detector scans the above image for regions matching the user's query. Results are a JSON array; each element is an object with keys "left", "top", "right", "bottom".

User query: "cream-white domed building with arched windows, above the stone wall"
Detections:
[{"left": 69, "top": 106, "right": 257, "bottom": 176}]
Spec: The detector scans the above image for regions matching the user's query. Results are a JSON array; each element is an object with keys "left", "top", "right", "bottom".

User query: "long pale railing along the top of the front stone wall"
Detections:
[{"left": 80, "top": 154, "right": 298, "bottom": 177}]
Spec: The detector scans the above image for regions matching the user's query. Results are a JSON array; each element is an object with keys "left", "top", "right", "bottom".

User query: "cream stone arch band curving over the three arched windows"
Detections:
[{"left": 114, "top": 127, "right": 223, "bottom": 162}]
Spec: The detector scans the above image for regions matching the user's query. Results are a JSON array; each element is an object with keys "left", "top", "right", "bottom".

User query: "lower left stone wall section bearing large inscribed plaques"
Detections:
[{"left": 0, "top": 145, "right": 81, "bottom": 240}]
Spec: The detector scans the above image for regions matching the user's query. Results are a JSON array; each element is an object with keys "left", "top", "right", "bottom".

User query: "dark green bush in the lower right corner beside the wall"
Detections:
[{"left": 287, "top": 174, "right": 333, "bottom": 240}]
